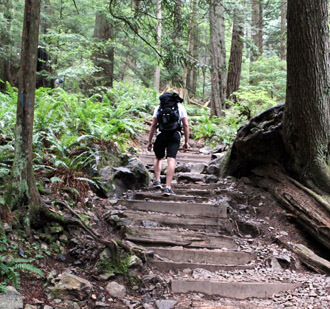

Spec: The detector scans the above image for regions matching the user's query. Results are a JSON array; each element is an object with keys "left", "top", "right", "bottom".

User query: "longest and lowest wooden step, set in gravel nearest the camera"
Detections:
[{"left": 171, "top": 279, "right": 301, "bottom": 299}]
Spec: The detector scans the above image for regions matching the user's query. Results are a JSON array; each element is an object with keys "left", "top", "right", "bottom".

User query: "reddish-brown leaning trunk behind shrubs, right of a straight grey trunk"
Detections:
[{"left": 227, "top": 3, "right": 244, "bottom": 100}]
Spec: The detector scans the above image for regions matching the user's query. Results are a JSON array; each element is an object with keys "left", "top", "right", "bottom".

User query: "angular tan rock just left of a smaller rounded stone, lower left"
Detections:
[{"left": 50, "top": 272, "right": 93, "bottom": 299}]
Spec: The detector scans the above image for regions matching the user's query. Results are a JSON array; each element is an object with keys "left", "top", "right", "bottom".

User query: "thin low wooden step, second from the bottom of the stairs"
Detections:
[{"left": 148, "top": 260, "right": 253, "bottom": 272}]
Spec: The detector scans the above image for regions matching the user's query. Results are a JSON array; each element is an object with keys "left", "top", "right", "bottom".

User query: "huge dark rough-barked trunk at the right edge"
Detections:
[{"left": 283, "top": 0, "right": 330, "bottom": 193}]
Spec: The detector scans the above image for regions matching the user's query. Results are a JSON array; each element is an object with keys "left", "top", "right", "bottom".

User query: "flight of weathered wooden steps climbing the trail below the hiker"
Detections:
[{"left": 114, "top": 151, "right": 310, "bottom": 308}]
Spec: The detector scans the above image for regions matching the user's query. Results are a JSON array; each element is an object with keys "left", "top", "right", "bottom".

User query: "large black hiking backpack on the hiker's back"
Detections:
[{"left": 157, "top": 93, "right": 183, "bottom": 133}]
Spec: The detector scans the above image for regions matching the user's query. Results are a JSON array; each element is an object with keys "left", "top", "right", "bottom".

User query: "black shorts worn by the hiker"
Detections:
[{"left": 154, "top": 131, "right": 181, "bottom": 159}]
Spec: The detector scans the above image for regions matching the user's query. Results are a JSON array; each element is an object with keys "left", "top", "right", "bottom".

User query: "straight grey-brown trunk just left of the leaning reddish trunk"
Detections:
[{"left": 210, "top": 0, "right": 226, "bottom": 116}]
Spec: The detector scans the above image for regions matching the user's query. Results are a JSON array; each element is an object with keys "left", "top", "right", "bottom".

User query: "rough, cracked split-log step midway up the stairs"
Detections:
[{"left": 125, "top": 226, "right": 236, "bottom": 249}]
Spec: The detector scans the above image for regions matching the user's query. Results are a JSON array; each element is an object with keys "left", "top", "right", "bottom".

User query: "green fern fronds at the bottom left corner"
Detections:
[{"left": 0, "top": 238, "right": 44, "bottom": 291}]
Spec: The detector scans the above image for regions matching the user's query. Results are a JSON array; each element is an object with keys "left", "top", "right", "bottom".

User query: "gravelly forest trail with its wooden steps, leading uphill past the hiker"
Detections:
[{"left": 110, "top": 141, "right": 329, "bottom": 309}]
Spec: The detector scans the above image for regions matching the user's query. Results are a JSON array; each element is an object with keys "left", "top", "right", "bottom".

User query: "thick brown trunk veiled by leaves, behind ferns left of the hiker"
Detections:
[{"left": 93, "top": 11, "right": 115, "bottom": 87}]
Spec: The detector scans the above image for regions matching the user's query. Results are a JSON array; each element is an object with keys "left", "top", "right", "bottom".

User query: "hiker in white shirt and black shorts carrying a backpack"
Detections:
[{"left": 148, "top": 93, "right": 189, "bottom": 195}]
